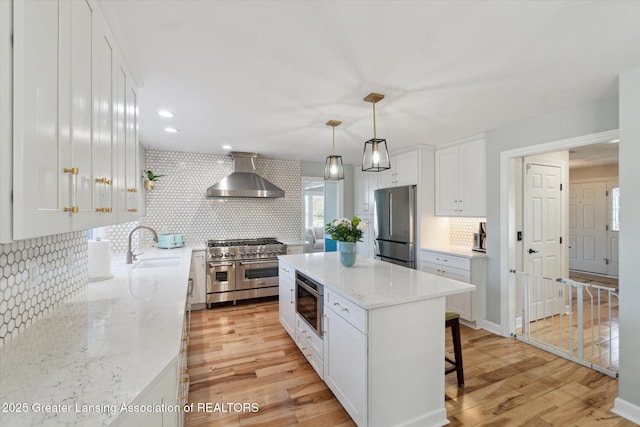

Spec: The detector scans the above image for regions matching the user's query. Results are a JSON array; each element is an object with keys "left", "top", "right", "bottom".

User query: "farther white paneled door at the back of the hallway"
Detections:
[{"left": 569, "top": 181, "right": 607, "bottom": 274}]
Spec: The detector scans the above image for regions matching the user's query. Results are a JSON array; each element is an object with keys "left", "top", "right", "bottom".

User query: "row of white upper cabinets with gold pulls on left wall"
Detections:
[{"left": 12, "top": 0, "right": 137, "bottom": 240}]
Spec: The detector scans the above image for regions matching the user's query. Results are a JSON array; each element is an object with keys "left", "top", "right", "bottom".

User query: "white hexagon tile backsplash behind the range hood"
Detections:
[{"left": 145, "top": 150, "right": 302, "bottom": 244}]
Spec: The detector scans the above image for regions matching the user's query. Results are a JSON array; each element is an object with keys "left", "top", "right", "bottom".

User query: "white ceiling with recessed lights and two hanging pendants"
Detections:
[{"left": 101, "top": 0, "right": 640, "bottom": 163}]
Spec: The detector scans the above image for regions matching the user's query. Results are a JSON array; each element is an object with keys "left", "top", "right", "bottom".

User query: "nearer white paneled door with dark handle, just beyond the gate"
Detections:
[{"left": 524, "top": 163, "right": 564, "bottom": 320}]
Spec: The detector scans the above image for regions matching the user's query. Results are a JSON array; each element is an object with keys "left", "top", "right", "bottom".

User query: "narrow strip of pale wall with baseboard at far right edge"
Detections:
[{"left": 614, "top": 69, "right": 640, "bottom": 423}]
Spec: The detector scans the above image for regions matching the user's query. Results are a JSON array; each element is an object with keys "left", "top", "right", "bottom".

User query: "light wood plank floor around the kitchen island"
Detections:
[{"left": 186, "top": 300, "right": 635, "bottom": 427}]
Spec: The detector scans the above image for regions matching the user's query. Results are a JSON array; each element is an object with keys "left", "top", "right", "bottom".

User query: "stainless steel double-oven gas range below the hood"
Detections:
[{"left": 207, "top": 238, "right": 287, "bottom": 307}]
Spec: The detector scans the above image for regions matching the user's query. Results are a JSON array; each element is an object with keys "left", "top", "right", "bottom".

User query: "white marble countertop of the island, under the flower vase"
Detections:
[{"left": 279, "top": 252, "right": 476, "bottom": 310}]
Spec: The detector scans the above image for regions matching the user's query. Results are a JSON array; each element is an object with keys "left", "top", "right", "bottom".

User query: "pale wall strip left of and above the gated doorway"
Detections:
[{"left": 486, "top": 98, "right": 618, "bottom": 324}]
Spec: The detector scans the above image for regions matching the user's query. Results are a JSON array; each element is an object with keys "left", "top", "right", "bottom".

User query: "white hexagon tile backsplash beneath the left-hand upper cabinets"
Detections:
[{"left": 0, "top": 231, "right": 88, "bottom": 346}]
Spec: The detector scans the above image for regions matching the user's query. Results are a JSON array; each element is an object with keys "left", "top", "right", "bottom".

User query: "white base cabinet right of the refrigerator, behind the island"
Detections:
[{"left": 418, "top": 249, "right": 486, "bottom": 327}]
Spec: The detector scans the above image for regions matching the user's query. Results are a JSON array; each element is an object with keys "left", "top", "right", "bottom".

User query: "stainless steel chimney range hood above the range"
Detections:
[{"left": 207, "top": 151, "right": 284, "bottom": 198}]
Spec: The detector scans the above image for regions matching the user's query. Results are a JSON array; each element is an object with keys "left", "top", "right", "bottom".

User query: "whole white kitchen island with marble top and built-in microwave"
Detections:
[{"left": 279, "top": 252, "right": 475, "bottom": 427}]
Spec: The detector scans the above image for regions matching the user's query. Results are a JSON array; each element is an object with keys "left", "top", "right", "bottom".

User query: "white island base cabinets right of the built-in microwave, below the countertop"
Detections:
[{"left": 324, "top": 287, "right": 446, "bottom": 427}]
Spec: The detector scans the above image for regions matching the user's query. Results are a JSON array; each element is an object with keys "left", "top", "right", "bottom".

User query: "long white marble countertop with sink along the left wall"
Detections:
[{"left": 0, "top": 247, "right": 192, "bottom": 426}]
